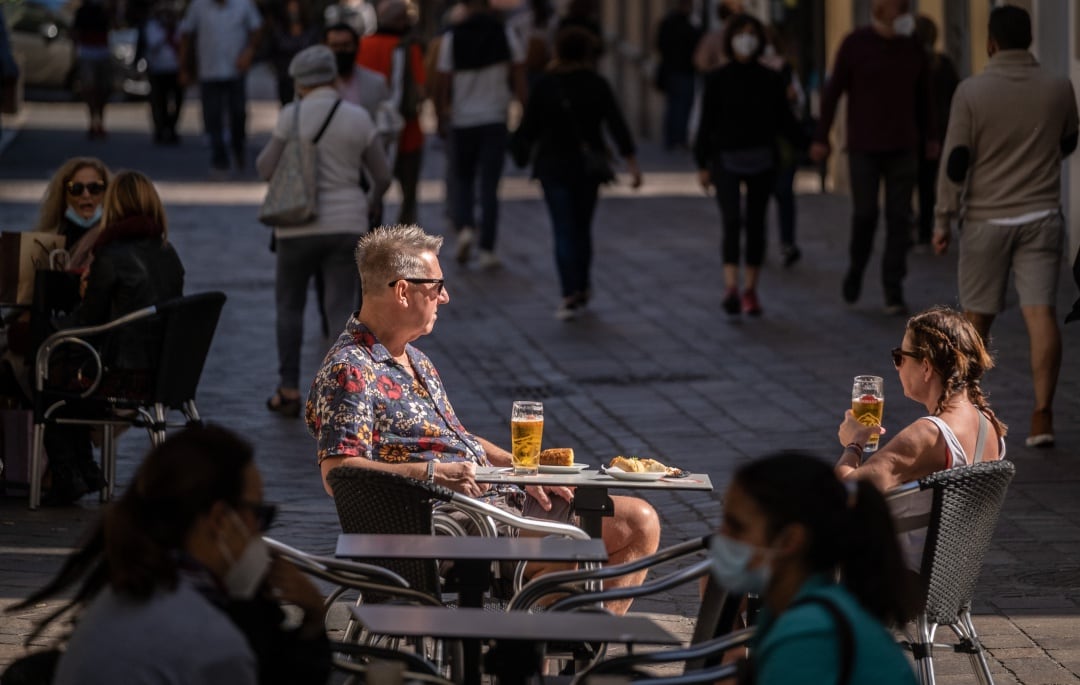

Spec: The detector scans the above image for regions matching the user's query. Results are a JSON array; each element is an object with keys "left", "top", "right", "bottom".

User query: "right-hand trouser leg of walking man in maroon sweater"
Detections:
[{"left": 881, "top": 152, "right": 918, "bottom": 314}]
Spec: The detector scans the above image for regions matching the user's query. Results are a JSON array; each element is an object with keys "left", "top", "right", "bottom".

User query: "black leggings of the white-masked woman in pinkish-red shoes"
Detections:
[{"left": 712, "top": 164, "right": 775, "bottom": 267}]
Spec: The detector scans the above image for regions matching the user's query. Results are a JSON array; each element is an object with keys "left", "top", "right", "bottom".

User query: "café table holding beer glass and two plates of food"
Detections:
[{"left": 476, "top": 466, "right": 713, "bottom": 538}]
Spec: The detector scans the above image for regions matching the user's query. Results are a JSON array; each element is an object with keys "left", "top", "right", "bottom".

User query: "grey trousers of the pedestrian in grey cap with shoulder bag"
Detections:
[{"left": 274, "top": 233, "right": 360, "bottom": 388}]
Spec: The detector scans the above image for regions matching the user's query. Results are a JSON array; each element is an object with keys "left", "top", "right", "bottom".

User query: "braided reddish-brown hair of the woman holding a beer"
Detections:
[{"left": 907, "top": 307, "right": 1008, "bottom": 438}]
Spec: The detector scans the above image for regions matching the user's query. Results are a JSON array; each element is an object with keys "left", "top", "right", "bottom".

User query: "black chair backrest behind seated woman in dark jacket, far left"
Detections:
[{"left": 152, "top": 292, "right": 225, "bottom": 408}]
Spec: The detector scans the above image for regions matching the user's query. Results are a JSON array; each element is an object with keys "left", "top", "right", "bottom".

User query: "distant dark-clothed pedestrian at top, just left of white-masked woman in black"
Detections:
[{"left": 657, "top": 0, "right": 701, "bottom": 150}]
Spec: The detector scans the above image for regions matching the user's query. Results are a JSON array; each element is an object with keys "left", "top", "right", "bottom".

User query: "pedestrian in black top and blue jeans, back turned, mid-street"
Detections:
[{"left": 512, "top": 27, "right": 642, "bottom": 321}]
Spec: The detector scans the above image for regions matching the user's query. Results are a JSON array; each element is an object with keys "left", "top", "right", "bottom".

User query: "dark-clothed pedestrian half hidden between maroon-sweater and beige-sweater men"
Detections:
[{"left": 915, "top": 14, "right": 960, "bottom": 250}]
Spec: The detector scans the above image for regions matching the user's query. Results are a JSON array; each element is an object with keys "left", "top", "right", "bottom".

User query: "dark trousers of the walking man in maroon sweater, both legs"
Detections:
[{"left": 848, "top": 150, "right": 918, "bottom": 305}]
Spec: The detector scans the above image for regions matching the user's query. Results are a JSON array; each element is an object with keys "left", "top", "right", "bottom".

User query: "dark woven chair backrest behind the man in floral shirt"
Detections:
[{"left": 326, "top": 466, "right": 441, "bottom": 597}]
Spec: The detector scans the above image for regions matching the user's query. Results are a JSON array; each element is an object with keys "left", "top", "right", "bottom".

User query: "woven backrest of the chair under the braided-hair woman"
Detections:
[{"left": 919, "top": 459, "right": 1016, "bottom": 626}]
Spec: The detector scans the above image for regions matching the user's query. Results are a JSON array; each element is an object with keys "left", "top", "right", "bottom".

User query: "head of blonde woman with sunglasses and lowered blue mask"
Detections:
[{"left": 33, "top": 157, "right": 110, "bottom": 268}]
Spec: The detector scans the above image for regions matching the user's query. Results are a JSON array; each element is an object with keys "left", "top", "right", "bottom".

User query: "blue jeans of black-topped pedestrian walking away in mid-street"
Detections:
[{"left": 540, "top": 176, "right": 598, "bottom": 297}]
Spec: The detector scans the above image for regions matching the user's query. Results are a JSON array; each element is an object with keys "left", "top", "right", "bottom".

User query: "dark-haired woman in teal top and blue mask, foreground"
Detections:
[{"left": 710, "top": 453, "right": 916, "bottom": 685}]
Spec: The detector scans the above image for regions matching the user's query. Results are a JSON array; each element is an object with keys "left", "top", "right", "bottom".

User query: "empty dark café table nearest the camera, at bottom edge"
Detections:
[{"left": 351, "top": 600, "right": 680, "bottom": 685}]
